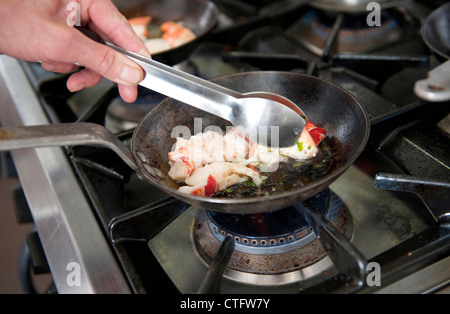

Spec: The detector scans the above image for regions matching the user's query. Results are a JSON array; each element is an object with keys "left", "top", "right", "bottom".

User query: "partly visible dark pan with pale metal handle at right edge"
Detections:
[{"left": 414, "top": 3, "right": 450, "bottom": 101}]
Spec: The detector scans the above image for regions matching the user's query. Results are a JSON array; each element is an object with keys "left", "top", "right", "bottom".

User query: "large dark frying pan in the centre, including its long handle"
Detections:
[{"left": 0, "top": 72, "right": 370, "bottom": 214}]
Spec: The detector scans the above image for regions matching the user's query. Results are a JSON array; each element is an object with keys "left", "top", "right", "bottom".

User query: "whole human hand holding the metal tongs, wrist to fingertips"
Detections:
[{"left": 0, "top": 0, "right": 150, "bottom": 102}]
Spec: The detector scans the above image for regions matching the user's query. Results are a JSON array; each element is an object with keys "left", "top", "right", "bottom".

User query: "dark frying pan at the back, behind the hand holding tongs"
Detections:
[{"left": 113, "top": 0, "right": 218, "bottom": 65}]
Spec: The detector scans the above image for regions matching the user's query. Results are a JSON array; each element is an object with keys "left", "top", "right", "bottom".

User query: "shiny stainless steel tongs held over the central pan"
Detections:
[{"left": 78, "top": 28, "right": 307, "bottom": 147}]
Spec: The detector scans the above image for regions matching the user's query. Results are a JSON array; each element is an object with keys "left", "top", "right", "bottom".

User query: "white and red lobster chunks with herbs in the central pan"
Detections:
[{"left": 168, "top": 122, "right": 326, "bottom": 197}]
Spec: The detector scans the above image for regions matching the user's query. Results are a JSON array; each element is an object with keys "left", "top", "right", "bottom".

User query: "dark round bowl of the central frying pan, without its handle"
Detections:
[{"left": 132, "top": 72, "right": 369, "bottom": 213}]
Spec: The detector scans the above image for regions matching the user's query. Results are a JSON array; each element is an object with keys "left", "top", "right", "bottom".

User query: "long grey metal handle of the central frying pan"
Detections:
[{"left": 0, "top": 122, "right": 138, "bottom": 171}]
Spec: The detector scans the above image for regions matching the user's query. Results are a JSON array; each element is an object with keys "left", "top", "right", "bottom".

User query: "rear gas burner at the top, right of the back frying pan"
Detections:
[{"left": 287, "top": 9, "right": 404, "bottom": 56}]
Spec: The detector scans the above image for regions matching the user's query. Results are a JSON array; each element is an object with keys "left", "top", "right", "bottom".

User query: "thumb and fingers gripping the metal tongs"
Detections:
[{"left": 59, "top": 0, "right": 150, "bottom": 102}]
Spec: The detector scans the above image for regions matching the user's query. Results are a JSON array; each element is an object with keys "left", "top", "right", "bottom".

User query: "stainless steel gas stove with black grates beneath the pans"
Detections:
[{"left": 0, "top": 0, "right": 450, "bottom": 294}]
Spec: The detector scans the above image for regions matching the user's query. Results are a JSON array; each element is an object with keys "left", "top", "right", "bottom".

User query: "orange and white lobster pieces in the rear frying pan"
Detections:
[{"left": 128, "top": 16, "right": 196, "bottom": 54}]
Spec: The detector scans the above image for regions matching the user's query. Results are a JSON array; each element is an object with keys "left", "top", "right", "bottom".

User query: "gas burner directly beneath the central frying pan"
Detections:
[{"left": 193, "top": 189, "right": 352, "bottom": 285}]
